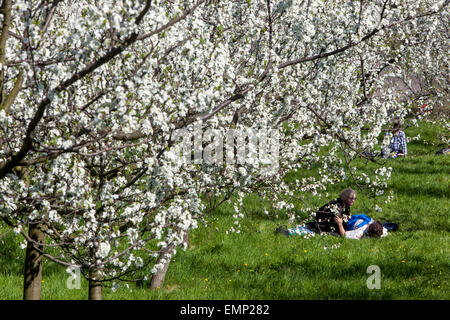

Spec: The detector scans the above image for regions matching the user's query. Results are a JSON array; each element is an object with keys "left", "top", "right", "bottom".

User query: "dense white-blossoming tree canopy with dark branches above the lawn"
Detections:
[{"left": 0, "top": 0, "right": 449, "bottom": 286}]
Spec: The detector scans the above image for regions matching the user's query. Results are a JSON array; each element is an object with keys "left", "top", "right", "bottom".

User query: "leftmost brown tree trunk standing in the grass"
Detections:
[{"left": 23, "top": 225, "right": 45, "bottom": 300}]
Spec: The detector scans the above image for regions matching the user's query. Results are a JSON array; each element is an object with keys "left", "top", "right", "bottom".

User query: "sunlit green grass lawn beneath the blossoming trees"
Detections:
[{"left": 0, "top": 120, "right": 450, "bottom": 300}]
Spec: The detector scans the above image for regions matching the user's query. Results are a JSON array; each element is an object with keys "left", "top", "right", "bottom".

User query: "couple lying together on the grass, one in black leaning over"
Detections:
[{"left": 276, "top": 188, "right": 398, "bottom": 239}]
